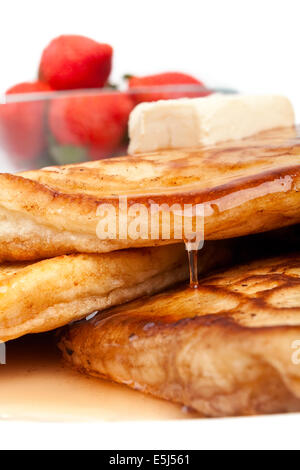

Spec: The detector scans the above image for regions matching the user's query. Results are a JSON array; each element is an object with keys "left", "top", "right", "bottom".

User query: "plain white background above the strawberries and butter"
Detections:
[{"left": 0, "top": 0, "right": 300, "bottom": 117}]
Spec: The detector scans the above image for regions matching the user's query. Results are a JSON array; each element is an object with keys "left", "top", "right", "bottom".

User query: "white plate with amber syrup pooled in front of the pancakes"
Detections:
[{"left": 0, "top": 334, "right": 300, "bottom": 450}]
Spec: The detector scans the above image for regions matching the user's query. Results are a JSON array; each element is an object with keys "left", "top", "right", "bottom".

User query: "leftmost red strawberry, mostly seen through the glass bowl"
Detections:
[{"left": 0, "top": 82, "right": 51, "bottom": 160}]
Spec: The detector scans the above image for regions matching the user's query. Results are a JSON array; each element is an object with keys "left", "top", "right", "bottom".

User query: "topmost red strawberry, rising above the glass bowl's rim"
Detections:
[{"left": 39, "top": 36, "right": 113, "bottom": 90}]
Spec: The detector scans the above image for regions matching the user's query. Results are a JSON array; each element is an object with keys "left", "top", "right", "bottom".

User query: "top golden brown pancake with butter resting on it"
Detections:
[{"left": 0, "top": 128, "right": 300, "bottom": 260}]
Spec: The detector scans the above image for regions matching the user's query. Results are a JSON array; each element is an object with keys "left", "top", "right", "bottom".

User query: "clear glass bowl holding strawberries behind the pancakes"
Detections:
[{"left": 0, "top": 85, "right": 234, "bottom": 172}]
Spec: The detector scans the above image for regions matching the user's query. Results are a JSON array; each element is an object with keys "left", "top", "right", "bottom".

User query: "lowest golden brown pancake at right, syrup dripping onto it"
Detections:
[{"left": 60, "top": 253, "right": 300, "bottom": 416}]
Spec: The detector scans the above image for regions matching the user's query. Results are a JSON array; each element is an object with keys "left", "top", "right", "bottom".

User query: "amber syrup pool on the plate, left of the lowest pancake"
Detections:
[{"left": 0, "top": 333, "right": 199, "bottom": 422}]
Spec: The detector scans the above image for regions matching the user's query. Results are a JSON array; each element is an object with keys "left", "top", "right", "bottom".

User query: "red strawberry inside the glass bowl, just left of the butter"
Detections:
[{"left": 49, "top": 93, "right": 133, "bottom": 160}]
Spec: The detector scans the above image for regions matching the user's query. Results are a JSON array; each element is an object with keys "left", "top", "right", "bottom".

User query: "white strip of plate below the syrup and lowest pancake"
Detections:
[{"left": 0, "top": 414, "right": 300, "bottom": 450}]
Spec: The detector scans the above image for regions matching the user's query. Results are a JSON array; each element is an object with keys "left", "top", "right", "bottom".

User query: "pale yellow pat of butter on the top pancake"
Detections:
[{"left": 129, "top": 94, "right": 295, "bottom": 154}]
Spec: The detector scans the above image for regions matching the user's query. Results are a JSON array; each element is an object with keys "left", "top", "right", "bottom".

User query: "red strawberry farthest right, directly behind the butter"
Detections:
[{"left": 129, "top": 72, "right": 210, "bottom": 103}]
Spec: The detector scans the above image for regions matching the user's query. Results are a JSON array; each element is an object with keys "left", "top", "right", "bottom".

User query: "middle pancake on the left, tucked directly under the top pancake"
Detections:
[{"left": 0, "top": 244, "right": 189, "bottom": 341}]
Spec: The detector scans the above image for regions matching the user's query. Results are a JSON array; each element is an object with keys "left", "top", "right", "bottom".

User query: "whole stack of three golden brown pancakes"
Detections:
[{"left": 0, "top": 128, "right": 300, "bottom": 416}]
